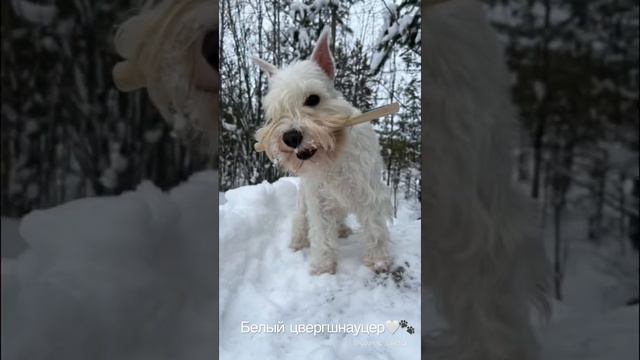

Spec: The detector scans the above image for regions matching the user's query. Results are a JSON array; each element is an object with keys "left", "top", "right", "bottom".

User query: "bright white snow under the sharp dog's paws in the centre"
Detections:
[{"left": 219, "top": 178, "right": 420, "bottom": 360}]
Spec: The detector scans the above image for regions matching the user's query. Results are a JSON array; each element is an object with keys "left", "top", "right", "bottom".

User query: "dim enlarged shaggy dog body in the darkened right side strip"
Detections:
[{"left": 422, "top": 0, "right": 550, "bottom": 360}]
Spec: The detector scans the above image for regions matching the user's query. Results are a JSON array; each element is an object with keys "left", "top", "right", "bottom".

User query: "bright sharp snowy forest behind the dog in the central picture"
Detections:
[{"left": 219, "top": 0, "right": 421, "bottom": 214}]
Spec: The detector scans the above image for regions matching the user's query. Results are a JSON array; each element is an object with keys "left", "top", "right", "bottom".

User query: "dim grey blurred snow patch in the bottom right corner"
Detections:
[{"left": 538, "top": 213, "right": 640, "bottom": 360}]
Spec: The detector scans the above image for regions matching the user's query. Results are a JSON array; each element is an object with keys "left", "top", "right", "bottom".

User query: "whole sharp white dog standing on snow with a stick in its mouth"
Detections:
[{"left": 254, "top": 29, "right": 391, "bottom": 275}]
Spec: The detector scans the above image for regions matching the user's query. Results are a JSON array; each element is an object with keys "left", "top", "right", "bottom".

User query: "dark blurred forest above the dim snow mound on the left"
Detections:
[{"left": 0, "top": 0, "right": 213, "bottom": 220}]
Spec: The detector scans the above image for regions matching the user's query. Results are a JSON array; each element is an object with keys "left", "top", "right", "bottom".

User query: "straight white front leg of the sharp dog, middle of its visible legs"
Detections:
[{"left": 305, "top": 193, "right": 339, "bottom": 275}]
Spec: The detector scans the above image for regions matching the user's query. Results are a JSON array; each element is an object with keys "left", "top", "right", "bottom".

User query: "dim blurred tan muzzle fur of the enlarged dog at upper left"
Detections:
[{"left": 113, "top": 0, "right": 218, "bottom": 143}]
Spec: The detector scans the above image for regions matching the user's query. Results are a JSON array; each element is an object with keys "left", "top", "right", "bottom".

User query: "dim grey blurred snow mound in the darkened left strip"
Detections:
[{"left": 2, "top": 172, "right": 217, "bottom": 360}]
